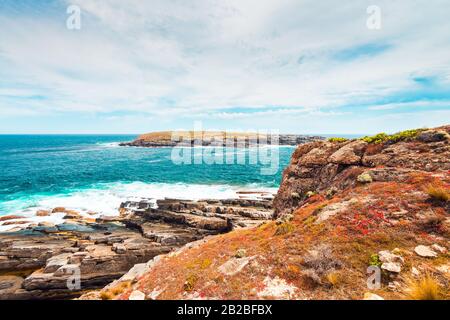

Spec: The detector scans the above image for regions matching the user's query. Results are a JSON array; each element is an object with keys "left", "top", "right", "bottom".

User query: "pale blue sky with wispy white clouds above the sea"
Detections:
[{"left": 0, "top": 0, "right": 450, "bottom": 134}]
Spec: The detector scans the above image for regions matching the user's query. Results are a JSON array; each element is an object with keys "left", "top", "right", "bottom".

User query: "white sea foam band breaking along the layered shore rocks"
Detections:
[{"left": 0, "top": 182, "right": 277, "bottom": 232}]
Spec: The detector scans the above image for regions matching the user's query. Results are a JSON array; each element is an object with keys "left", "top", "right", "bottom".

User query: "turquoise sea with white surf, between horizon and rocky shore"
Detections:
[{"left": 0, "top": 135, "right": 294, "bottom": 215}]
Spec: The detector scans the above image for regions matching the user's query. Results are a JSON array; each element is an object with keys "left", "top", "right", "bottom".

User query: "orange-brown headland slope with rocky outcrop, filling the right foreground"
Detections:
[{"left": 83, "top": 126, "right": 450, "bottom": 300}]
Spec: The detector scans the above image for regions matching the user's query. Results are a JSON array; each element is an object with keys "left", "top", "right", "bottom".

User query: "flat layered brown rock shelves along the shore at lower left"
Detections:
[{"left": 0, "top": 194, "right": 273, "bottom": 300}]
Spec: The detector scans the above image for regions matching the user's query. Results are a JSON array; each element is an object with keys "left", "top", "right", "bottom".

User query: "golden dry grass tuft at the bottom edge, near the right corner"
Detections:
[{"left": 406, "top": 274, "right": 442, "bottom": 300}]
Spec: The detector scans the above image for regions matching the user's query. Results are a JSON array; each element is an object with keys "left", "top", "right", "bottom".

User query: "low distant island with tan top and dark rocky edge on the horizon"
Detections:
[{"left": 120, "top": 131, "right": 325, "bottom": 148}]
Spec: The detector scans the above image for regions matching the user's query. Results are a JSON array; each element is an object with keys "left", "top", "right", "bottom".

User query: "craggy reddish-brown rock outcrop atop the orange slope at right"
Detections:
[{"left": 274, "top": 126, "right": 450, "bottom": 216}]
